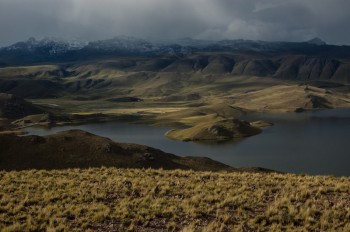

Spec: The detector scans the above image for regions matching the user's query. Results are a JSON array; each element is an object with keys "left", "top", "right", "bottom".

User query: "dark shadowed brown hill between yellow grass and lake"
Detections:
[{"left": 0, "top": 130, "right": 234, "bottom": 170}]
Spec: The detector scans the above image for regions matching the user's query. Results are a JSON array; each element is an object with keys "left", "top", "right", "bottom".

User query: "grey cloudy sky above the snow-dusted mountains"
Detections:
[{"left": 0, "top": 0, "right": 350, "bottom": 46}]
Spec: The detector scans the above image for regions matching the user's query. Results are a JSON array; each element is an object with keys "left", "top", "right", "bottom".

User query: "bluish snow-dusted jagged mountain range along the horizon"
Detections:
[{"left": 0, "top": 36, "right": 350, "bottom": 66}]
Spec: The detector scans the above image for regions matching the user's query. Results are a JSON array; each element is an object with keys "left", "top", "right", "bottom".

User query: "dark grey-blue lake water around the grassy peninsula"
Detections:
[{"left": 27, "top": 109, "right": 350, "bottom": 176}]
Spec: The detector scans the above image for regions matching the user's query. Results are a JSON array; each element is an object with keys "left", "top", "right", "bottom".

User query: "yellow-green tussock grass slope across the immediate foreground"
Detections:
[{"left": 0, "top": 168, "right": 350, "bottom": 231}]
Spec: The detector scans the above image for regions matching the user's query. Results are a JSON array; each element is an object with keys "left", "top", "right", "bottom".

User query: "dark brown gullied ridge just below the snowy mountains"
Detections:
[{"left": 0, "top": 51, "right": 350, "bottom": 86}]
